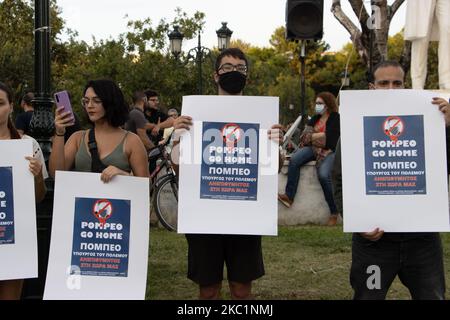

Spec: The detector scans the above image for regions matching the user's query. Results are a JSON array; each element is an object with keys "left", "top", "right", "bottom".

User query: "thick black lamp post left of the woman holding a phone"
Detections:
[{"left": 22, "top": 0, "right": 54, "bottom": 299}]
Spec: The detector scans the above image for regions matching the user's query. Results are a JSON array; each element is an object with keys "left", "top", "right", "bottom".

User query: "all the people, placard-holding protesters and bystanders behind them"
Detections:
[{"left": 0, "top": 48, "right": 450, "bottom": 299}]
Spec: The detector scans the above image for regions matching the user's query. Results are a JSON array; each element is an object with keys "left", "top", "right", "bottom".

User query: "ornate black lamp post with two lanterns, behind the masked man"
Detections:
[{"left": 169, "top": 22, "right": 233, "bottom": 95}]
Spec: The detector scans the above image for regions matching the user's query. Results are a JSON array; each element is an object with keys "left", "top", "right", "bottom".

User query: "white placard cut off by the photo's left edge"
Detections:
[{"left": 0, "top": 139, "right": 38, "bottom": 280}]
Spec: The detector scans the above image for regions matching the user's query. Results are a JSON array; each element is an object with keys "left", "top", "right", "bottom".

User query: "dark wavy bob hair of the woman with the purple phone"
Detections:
[{"left": 83, "top": 79, "right": 129, "bottom": 128}]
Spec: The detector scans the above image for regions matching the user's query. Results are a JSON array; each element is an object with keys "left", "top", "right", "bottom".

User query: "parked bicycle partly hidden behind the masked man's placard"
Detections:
[{"left": 148, "top": 141, "right": 178, "bottom": 231}]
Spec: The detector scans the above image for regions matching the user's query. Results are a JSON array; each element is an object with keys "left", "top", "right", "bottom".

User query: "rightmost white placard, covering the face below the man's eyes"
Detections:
[{"left": 340, "top": 90, "right": 450, "bottom": 232}]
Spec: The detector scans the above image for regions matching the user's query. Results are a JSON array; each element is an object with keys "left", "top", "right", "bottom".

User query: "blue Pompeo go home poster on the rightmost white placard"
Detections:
[{"left": 364, "top": 115, "right": 427, "bottom": 195}]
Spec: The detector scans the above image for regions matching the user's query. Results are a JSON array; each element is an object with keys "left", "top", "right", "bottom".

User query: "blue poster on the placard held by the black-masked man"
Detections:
[{"left": 200, "top": 122, "right": 259, "bottom": 201}]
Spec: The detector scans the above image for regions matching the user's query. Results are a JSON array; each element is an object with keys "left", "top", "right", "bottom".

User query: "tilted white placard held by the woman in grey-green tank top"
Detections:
[{"left": 44, "top": 171, "right": 150, "bottom": 300}]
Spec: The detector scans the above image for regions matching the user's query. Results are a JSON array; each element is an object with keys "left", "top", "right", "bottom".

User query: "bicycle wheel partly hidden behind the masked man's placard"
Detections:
[{"left": 154, "top": 174, "right": 178, "bottom": 231}]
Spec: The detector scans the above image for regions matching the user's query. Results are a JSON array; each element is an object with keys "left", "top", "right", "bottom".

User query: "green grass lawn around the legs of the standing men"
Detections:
[{"left": 146, "top": 226, "right": 450, "bottom": 300}]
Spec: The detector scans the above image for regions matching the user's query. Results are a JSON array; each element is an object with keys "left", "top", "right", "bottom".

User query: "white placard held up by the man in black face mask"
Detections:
[{"left": 178, "top": 96, "right": 279, "bottom": 235}]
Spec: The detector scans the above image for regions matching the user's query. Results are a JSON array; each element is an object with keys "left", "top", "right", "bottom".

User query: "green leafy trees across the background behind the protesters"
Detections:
[{"left": 4, "top": 0, "right": 437, "bottom": 131}]
